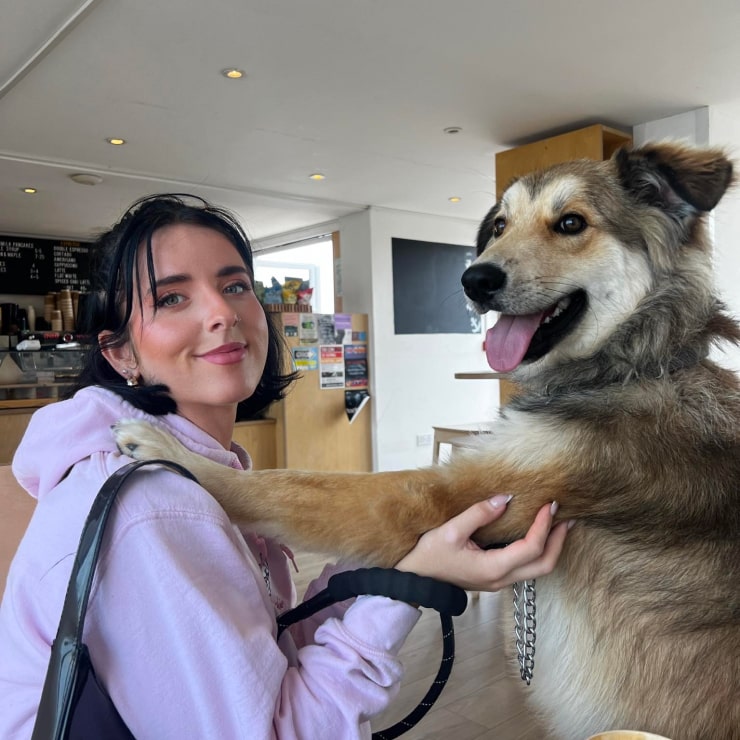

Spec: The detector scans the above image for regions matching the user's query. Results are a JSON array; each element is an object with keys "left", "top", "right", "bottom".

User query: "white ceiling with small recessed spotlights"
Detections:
[{"left": 0, "top": 0, "right": 740, "bottom": 244}]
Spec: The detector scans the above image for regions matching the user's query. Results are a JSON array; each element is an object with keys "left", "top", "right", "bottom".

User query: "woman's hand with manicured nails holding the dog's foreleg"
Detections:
[{"left": 396, "top": 495, "right": 570, "bottom": 591}]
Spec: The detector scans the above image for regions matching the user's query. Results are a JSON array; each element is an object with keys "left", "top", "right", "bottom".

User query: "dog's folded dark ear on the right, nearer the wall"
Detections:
[{"left": 614, "top": 142, "right": 733, "bottom": 218}]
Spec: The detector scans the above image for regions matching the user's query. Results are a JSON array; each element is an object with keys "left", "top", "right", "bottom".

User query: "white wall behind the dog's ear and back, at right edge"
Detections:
[{"left": 633, "top": 101, "right": 740, "bottom": 372}]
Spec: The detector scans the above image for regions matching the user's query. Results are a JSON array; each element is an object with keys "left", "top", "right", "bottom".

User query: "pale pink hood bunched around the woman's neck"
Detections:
[{"left": 13, "top": 387, "right": 251, "bottom": 498}]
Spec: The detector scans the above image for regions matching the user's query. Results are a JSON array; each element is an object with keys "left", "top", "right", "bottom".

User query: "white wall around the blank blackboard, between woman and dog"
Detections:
[{"left": 340, "top": 208, "right": 498, "bottom": 470}]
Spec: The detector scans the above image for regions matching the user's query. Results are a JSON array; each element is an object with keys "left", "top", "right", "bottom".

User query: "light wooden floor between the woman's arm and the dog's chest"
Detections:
[{"left": 295, "top": 553, "right": 547, "bottom": 740}]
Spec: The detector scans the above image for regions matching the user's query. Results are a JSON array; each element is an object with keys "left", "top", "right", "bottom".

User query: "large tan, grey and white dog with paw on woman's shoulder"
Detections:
[{"left": 117, "top": 143, "right": 740, "bottom": 740}]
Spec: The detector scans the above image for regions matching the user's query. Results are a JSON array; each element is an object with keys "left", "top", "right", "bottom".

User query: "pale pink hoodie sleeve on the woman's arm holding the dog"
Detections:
[{"left": 86, "top": 486, "right": 419, "bottom": 740}]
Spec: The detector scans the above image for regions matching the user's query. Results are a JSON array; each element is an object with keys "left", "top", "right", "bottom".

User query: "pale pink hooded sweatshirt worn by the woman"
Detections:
[{"left": 0, "top": 388, "right": 419, "bottom": 740}]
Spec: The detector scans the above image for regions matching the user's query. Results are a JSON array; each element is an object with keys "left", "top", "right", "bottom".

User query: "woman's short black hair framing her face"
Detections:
[{"left": 71, "top": 193, "right": 297, "bottom": 419}]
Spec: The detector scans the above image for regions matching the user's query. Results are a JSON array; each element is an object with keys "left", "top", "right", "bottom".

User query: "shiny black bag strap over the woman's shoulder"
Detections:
[{"left": 32, "top": 460, "right": 197, "bottom": 740}]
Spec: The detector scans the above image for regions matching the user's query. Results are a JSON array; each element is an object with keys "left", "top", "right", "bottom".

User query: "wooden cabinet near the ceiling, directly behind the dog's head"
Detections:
[{"left": 496, "top": 124, "right": 632, "bottom": 405}]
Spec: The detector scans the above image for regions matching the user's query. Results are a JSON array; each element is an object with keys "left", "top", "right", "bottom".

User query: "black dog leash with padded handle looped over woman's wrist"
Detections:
[{"left": 277, "top": 568, "right": 468, "bottom": 740}]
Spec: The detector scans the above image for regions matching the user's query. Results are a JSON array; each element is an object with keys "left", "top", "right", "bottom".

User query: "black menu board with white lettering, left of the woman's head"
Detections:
[{"left": 0, "top": 235, "right": 92, "bottom": 295}]
